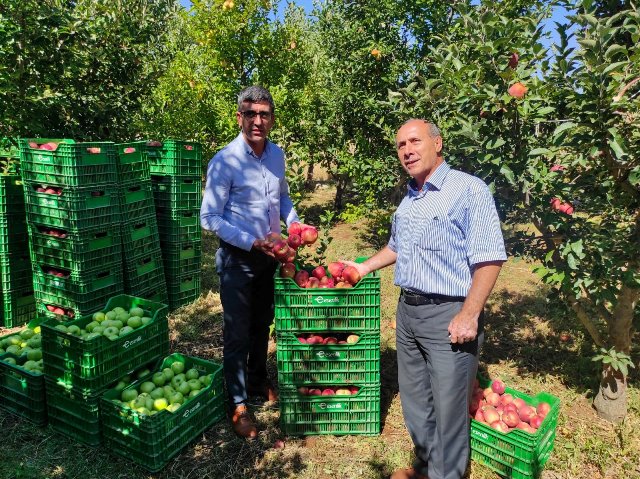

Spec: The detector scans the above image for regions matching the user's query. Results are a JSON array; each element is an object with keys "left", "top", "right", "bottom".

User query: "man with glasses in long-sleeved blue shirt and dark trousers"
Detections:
[{"left": 200, "top": 86, "right": 299, "bottom": 438}]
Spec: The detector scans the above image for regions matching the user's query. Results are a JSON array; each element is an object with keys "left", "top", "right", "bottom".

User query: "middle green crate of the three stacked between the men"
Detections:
[{"left": 276, "top": 331, "right": 380, "bottom": 385}]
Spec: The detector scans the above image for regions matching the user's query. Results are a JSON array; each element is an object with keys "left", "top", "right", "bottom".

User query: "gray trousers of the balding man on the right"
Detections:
[{"left": 396, "top": 297, "right": 484, "bottom": 479}]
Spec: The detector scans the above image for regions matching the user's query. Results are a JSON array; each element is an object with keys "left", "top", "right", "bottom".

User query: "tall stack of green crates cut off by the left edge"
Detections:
[{"left": 0, "top": 174, "right": 36, "bottom": 328}]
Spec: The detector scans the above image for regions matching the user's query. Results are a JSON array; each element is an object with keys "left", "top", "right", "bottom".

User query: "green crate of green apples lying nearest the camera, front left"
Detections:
[{"left": 101, "top": 354, "right": 225, "bottom": 472}]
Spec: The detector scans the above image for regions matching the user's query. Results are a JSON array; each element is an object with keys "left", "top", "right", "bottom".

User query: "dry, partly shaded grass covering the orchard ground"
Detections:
[{"left": 0, "top": 198, "right": 640, "bottom": 479}]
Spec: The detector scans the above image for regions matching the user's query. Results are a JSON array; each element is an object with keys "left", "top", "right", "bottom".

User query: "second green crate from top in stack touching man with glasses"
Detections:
[{"left": 151, "top": 176, "right": 202, "bottom": 210}]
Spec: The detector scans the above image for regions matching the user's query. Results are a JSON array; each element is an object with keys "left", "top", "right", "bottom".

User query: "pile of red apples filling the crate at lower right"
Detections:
[{"left": 469, "top": 379, "right": 551, "bottom": 434}]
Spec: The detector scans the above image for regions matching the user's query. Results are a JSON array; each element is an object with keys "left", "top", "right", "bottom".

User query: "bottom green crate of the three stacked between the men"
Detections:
[{"left": 280, "top": 383, "right": 380, "bottom": 436}]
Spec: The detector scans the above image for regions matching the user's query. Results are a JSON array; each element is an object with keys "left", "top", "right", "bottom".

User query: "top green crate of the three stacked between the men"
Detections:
[{"left": 274, "top": 268, "right": 380, "bottom": 332}]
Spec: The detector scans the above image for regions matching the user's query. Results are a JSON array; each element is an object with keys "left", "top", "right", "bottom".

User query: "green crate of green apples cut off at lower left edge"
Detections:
[{"left": 0, "top": 318, "right": 47, "bottom": 426}]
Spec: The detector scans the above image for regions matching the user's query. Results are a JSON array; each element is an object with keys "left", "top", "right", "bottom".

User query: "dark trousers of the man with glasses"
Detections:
[{"left": 216, "top": 241, "right": 277, "bottom": 406}]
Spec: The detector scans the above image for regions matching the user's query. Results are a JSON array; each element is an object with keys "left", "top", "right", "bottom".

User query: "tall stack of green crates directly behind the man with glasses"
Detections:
[{"left": 149, "top": 140, "right": 202, "bottom": 309}]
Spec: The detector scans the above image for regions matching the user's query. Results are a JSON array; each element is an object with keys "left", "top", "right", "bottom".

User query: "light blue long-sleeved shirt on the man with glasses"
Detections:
[{"left": 200, "top": 133, "right": 299, "bottom": 251}]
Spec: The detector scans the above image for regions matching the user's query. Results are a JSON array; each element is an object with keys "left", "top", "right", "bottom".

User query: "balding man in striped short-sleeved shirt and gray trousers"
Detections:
[{"left": 350, "top": 119, "right": 507, "bottom": 479}]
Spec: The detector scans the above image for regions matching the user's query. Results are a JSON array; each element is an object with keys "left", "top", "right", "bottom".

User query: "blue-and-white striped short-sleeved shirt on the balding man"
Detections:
[{"left": 389, "top": 163, "right": 507, "bottom": 296}]
